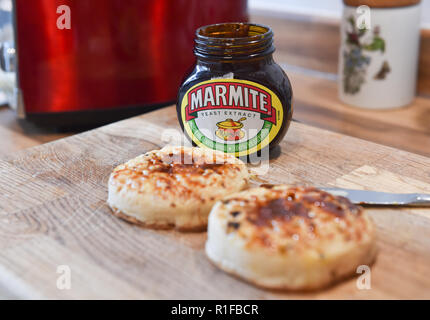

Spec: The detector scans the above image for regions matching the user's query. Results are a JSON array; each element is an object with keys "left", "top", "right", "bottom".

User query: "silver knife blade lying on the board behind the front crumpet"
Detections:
[{"left": 320, "top": 188, "right": 430, "bottom": 207}]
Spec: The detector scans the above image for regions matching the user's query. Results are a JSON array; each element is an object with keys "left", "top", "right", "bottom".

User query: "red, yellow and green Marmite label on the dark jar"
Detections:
[{"left": 181, "top": 79, "right": 284, "bottom": 156}]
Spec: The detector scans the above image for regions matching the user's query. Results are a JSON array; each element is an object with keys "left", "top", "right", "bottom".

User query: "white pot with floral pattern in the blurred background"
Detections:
[{"left": 339, "top": 0, "right": 420, "bottom": 109}]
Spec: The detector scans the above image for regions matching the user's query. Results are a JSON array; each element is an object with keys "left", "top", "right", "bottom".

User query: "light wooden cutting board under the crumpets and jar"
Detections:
[{"left": 0, "top": 107, "right": 430, "bottom": 299}]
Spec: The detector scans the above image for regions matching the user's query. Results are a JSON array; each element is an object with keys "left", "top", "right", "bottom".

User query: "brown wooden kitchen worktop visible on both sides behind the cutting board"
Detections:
[{"left": 0, "top": 67, "right": 430, "bottom": 156}]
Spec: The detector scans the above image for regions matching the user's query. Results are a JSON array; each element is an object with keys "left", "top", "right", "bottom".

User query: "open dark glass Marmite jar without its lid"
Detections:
[{"left": 177, "top": 23, "right": 293, "bottom": 157}]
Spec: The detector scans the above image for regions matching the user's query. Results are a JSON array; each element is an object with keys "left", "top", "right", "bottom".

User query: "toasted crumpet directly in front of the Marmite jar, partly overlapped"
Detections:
[{"left": 108, "top": 146, "right": 249, "bottom": 231}]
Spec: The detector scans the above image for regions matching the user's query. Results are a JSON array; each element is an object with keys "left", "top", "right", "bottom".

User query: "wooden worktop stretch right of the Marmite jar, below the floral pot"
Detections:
[{"left": 285, "top": 72, "right": 430, "bottom": 156}]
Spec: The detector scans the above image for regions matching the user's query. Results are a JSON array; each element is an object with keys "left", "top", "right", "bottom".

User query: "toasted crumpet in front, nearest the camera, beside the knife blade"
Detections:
[{"left": 206, "top": 185, "right": 376, "bottom": 290}]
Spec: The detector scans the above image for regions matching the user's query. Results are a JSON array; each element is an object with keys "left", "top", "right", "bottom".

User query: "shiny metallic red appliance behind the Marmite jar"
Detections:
[{"left": 10, "top": 0, "right": 248, "bottom": 125}]
